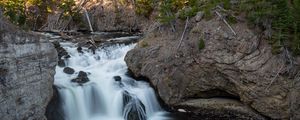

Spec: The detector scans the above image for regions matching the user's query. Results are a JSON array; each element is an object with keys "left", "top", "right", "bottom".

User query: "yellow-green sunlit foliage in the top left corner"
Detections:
[{"left": 0, "top": 0, "right": 81, "bottom": 28}]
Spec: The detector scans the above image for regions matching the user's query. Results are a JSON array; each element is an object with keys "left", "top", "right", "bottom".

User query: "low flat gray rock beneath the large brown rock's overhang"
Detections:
[{"left": 176, "top": 98, "right": 266, "bottom": 120}]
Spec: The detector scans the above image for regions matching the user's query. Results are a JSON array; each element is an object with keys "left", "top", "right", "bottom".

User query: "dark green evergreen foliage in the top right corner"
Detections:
[{"left": 241, "top": 0, "right": 300, "bottom": 55}]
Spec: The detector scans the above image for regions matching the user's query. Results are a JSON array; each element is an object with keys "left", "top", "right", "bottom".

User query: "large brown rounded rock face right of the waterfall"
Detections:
[{"left": 125, "top": 15, "right": 300, "bottom": 119}]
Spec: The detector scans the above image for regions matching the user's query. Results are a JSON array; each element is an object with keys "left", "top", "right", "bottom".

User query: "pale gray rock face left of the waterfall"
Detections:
[{"left": 0, "top": 15, "right": 57, "bottom": 120}]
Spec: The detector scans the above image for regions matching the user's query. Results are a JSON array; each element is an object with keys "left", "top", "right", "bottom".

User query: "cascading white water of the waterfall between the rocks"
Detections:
[{"left": 54, "top": 43, "right": 169, "bottom": 120}]
